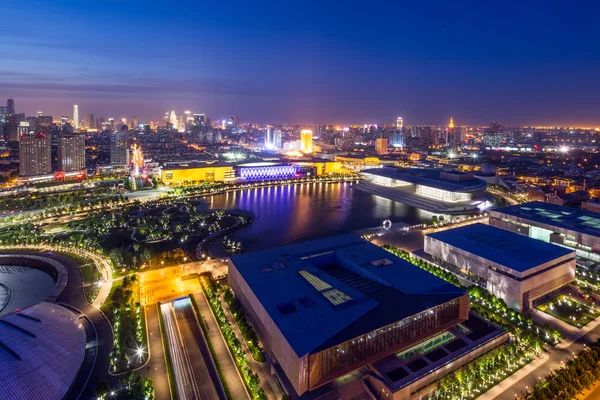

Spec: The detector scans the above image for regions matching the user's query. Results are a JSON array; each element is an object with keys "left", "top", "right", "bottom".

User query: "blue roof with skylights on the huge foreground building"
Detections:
[{"left": 230, "top": 234, "right": 465, "bottom": 357}]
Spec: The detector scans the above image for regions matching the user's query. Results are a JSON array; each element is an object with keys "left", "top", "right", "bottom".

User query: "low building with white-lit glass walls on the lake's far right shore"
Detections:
[{"left": 354, "top": 166, "right": 487, "bottom": 214}]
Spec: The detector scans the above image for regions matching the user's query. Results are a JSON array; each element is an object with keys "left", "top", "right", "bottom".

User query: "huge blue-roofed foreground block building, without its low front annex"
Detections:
[{"left": 228, "top": 234, "right": 468, "bottom": 394}]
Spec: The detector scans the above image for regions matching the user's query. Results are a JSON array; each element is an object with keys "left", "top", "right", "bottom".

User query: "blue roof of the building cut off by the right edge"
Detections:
[{"left": 491, "top": 201, "right": 600, "bottom": 236}]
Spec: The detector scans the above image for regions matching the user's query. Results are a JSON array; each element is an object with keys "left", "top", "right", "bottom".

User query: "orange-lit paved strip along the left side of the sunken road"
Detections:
[{"left": 137, "top": 304, "right": 171, "bottom": 400}]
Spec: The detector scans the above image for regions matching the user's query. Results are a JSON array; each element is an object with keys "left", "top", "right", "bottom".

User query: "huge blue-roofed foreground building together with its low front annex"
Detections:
[{"left": 228, "top": 234, "right": 506, "bottom": 400}]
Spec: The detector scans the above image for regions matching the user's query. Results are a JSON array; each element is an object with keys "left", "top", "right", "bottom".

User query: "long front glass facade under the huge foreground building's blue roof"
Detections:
[{"left": 309, "top": 299, "right": 460, "bottom": 389}]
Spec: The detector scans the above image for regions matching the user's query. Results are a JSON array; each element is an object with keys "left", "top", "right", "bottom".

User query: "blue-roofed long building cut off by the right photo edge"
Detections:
[{"left": 490, "top": 201, "right": 600, "bottom": 262}]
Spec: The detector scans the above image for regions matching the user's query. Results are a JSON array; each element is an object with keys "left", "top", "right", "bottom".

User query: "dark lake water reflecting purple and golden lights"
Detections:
[{"left": 206, "top": 183, "right": 431, "bottom": 251}]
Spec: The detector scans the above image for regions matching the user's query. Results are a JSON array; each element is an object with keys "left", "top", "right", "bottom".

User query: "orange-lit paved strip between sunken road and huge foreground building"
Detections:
[{"left": 193, "top": 293, "right": 248, "bottom": 400}]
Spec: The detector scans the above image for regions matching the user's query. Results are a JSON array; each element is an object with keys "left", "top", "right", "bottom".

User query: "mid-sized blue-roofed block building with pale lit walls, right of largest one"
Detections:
[{"left": 424, "top": 223, "right": 575, "bottom": 311}]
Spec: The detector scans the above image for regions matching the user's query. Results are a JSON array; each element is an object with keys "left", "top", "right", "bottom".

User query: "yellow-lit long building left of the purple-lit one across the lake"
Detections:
[{"left": 160, "top": 164, "right": 235, "bottom": 186}]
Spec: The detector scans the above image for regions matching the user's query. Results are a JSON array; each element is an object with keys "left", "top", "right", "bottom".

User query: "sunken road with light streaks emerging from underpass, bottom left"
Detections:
[{"left": 174, "top": 298, "right": 226, "bottom": 400}]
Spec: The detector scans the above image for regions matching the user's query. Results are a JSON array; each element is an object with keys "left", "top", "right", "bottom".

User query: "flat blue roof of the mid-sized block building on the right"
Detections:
[{"left": 427, "top": 223, "right": 574, "bottom": 272}]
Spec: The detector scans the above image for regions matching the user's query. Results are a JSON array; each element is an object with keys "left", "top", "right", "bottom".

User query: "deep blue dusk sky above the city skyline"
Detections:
[{"left": 0, "top": 0, "right": 600, "bottom": 126}]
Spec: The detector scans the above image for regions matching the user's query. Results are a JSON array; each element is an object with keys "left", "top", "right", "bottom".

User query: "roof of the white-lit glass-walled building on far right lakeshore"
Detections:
[{"left": 362, "top": 167, "right": 487, "bottom": 192}]
